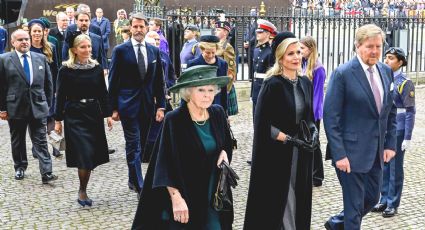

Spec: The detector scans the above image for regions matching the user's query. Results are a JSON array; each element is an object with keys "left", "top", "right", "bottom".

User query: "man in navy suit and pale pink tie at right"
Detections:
[{"left": 324, "top": 24, "right": 396, "bottom": 230}]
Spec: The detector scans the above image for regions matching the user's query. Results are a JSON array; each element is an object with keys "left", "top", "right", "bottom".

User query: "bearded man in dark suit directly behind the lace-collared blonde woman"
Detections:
[{"left": 62, "top": 11, "right": 108, "bottom": 73}]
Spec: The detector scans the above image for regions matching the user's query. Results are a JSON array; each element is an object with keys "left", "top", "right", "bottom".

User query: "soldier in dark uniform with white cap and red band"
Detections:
[{"left": 251, "top": 19, "right": 276, "bottom": 117}]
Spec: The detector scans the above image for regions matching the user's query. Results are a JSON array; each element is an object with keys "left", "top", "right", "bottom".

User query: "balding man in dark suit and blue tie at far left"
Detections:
[{"left": 0, "top": 29, "right": 57, "bottom": 184}]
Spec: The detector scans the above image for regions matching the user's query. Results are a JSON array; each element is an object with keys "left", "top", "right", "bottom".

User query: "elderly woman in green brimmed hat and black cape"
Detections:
[{"left": 132, "top": 65, "right": 233, "bottom": 229}]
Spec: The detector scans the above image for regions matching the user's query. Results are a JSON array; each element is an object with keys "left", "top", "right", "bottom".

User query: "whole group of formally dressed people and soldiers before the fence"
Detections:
[{"left": 0, "top": 4, "right": 415, "bottom": 229}]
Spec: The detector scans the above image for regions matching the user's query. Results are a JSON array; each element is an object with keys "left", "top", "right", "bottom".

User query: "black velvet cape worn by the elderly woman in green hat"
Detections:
[{"left": 132, "top": 103, "right": 233, "bottom": 230}]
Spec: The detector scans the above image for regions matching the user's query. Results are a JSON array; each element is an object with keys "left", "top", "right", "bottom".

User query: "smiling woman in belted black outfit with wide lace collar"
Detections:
[{"left": 54, "top": 31, "right": 112, "bottom": 207}]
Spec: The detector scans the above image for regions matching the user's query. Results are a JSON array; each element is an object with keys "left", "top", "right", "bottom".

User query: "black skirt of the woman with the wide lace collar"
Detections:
[{"left": 64, "top": 100, "right": 109, "bottom": 170}]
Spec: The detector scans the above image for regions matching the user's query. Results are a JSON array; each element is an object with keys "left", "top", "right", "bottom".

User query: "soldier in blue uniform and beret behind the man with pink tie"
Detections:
[{"left": 372, "top": 47, "right": 416, "bottom": 217}]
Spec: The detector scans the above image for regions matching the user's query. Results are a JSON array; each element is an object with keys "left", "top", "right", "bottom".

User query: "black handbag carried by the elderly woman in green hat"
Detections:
[{"left": 212, "top": 161, "right": 239, "bottom": 212}]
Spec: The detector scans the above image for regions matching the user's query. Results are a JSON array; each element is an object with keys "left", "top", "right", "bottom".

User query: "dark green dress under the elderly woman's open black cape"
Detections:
[{"left": 193, "top": 120, "right": 221, "bottom": 230}]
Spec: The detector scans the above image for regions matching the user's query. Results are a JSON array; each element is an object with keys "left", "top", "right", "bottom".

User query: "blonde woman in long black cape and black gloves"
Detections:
[{"left": 244, "top": 38, "right": 317, "bottom": 230}]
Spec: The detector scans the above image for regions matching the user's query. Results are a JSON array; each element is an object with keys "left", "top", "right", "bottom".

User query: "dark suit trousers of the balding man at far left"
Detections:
[{"left": 8, "top": 118, "right": 52, "bottom": 175}]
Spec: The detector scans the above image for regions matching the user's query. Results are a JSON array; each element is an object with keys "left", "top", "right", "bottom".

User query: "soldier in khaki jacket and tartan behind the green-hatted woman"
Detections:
[{"left": 215, "top": 21, "right": 238, "bottom": 116}]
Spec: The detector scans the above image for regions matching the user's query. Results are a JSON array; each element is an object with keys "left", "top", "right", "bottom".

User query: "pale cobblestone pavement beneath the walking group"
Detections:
[{"left": 0, "top": 88, "right": 425, "bottom": 230}]
